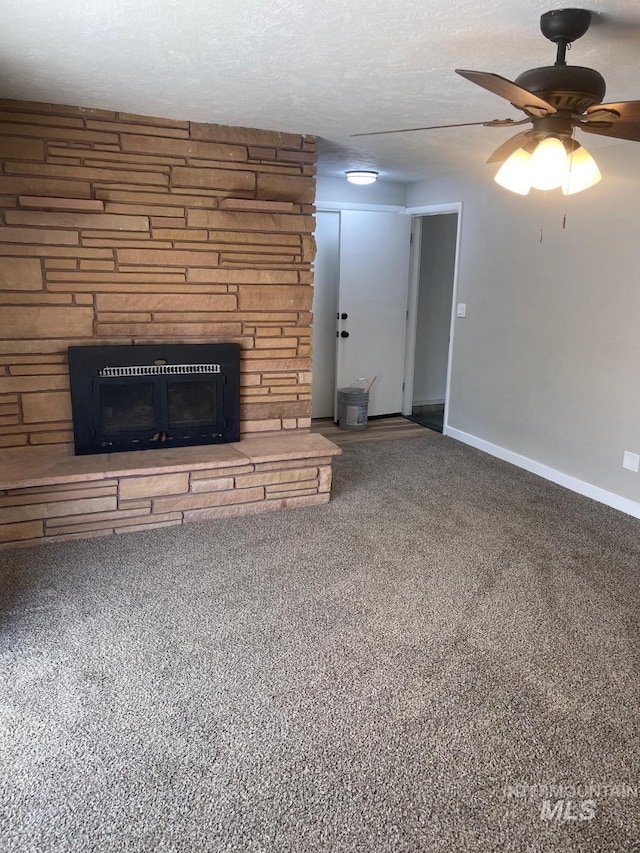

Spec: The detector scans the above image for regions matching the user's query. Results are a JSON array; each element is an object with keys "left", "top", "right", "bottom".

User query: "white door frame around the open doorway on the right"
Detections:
[{"left": 402, "top": 202, "right": 462, "bottom": 435}]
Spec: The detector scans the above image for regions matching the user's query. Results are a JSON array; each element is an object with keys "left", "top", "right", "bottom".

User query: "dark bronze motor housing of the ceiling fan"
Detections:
[{"left": 514, "top": 65, "right": 606, "bottom": 113}]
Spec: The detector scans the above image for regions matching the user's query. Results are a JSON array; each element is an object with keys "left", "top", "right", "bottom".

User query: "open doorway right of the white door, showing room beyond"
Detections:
[{"left": 403, "top": 210, "right": 459, "bottom": 432}]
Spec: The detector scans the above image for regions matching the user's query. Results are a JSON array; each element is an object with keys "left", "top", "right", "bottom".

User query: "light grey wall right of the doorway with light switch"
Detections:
[{"left": 407, "top": 142, "right": 640, "bottom": 510}]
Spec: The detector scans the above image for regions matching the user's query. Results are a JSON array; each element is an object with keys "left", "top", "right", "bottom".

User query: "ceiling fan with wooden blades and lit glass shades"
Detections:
[{"left": 353, "top": 9, "right": 640, "bottom": 195}]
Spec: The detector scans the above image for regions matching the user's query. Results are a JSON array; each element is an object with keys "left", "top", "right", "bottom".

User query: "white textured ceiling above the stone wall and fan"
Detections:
[{"left": 0, "top": 0, "right": 640, "bottom": 181}]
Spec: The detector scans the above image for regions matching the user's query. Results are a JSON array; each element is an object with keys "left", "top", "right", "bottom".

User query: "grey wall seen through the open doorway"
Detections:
[{"left": 413, "top": 213, "right": 458, "bottom": 406}]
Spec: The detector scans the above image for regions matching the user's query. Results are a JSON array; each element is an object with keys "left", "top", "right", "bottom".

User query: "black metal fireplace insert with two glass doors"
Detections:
[{"left": 69, "top": 344, "right": 240, "bottom": 455}]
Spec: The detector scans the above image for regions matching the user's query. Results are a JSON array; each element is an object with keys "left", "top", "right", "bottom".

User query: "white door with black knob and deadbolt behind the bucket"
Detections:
[{"left": 337, "top": 210, "right": 411, "bottom": 415}]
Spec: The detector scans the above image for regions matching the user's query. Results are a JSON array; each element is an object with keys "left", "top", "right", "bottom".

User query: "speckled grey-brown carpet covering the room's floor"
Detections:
[{"left": 0, "top": 437, "right": 640, "bottom": 853}]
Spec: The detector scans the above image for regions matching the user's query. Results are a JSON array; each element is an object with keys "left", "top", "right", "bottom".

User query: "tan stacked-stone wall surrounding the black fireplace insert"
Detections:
[{"left": 0, "top": 101, "right": 315, "bottom": 447}]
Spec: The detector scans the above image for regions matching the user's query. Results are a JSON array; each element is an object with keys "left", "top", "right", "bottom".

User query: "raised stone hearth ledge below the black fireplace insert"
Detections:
[{"left": 0, "top": 433, "right": 341, "bottom": 547}]
